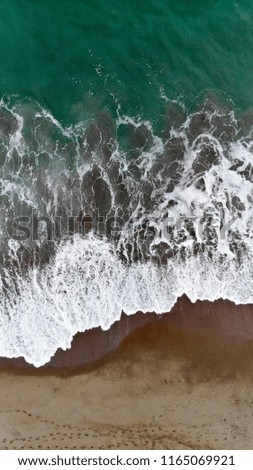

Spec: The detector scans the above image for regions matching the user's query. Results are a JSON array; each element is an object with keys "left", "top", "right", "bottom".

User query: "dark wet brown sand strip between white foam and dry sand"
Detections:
[{"left": 0, "top": 295, "right": 253, "bottom": 377}]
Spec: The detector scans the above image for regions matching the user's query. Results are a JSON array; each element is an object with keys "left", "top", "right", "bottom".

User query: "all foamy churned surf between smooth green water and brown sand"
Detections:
[{"left": 0, "top": 94, "right": 253, "bottom": 366}]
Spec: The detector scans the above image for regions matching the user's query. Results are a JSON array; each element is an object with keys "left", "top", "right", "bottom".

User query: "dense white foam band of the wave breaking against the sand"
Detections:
[{"left": 0, "top": 236, "right": 253, "bottom": 367}]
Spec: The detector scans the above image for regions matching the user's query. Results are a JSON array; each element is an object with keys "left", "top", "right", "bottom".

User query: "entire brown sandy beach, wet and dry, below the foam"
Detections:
[{"left": 0, "top": 297, "right": 253, "bottom": 449}]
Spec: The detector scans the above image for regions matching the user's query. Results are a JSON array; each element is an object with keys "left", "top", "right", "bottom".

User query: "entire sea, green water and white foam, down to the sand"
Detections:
[{"left": 0, "top": 0, "right": 253, "bottom": 366}]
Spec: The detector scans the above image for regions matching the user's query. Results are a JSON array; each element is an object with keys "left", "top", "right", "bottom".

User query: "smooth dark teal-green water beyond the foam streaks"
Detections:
[{"left": 0, "top": 0, "right": 253, "bottom": 123}]
